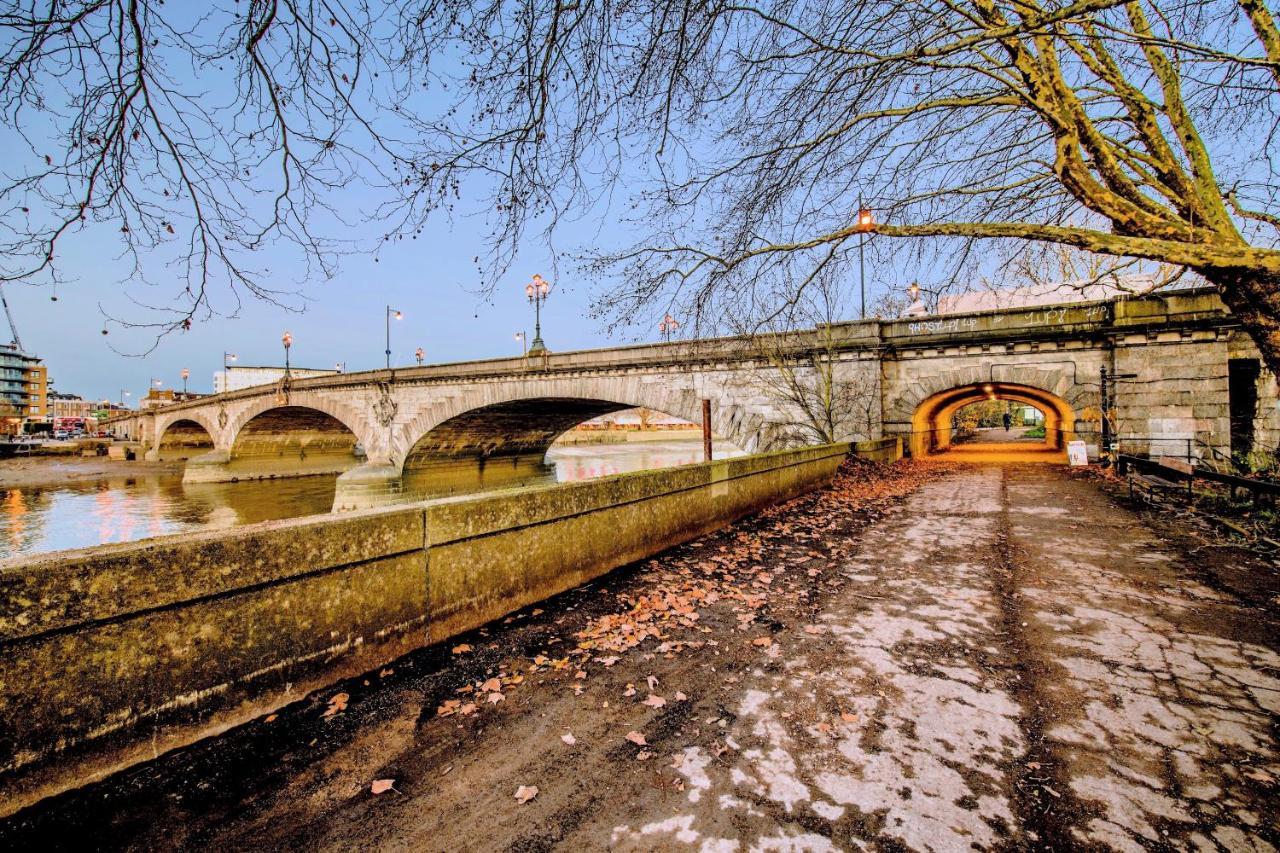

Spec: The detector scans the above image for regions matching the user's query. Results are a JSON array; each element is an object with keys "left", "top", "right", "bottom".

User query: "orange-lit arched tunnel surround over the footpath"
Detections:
[{"left": 910, "top": 382, "right": 1075, "bottom": 456}]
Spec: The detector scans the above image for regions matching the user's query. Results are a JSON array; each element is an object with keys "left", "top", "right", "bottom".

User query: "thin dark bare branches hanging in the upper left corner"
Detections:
[{"left": 0, "top": 0, "right": 394, "bottom": 330}]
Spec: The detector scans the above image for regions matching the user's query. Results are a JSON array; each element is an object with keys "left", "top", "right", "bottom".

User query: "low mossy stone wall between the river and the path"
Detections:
[{"left": 0, "top": 444, "right": 849, "bottom": 813}]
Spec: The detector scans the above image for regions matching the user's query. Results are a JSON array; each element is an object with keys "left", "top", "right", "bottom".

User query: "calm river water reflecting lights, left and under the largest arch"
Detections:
[{"left": 0, "top": 438, "right": 741, "bottom": 558}]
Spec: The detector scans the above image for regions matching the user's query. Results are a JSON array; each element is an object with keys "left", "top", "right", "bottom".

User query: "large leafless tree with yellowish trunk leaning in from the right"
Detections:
[{"left": 386, "top": 0, "right": 1280, "bottom": 371}]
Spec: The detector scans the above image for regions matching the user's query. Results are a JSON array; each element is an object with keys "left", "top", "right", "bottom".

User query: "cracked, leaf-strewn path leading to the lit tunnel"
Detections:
[{"left": 0, "top": 465, "right": 1280, "bottom": 850}]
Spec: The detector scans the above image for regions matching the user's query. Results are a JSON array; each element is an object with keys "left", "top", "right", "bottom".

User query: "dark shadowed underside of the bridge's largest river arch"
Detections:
[{"left": 407, "top": 397, "right": 634, "bottom": 462}]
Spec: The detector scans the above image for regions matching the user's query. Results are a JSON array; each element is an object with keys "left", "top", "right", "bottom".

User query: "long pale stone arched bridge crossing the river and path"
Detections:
[{"left": 111, "top": 289, "right": 1280, "bottom": 508}]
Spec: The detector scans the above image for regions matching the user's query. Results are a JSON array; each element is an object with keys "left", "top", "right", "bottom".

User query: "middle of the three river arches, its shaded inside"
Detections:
[{"left": 228, "top": 406, "right": 362, "bottom": 479}]
